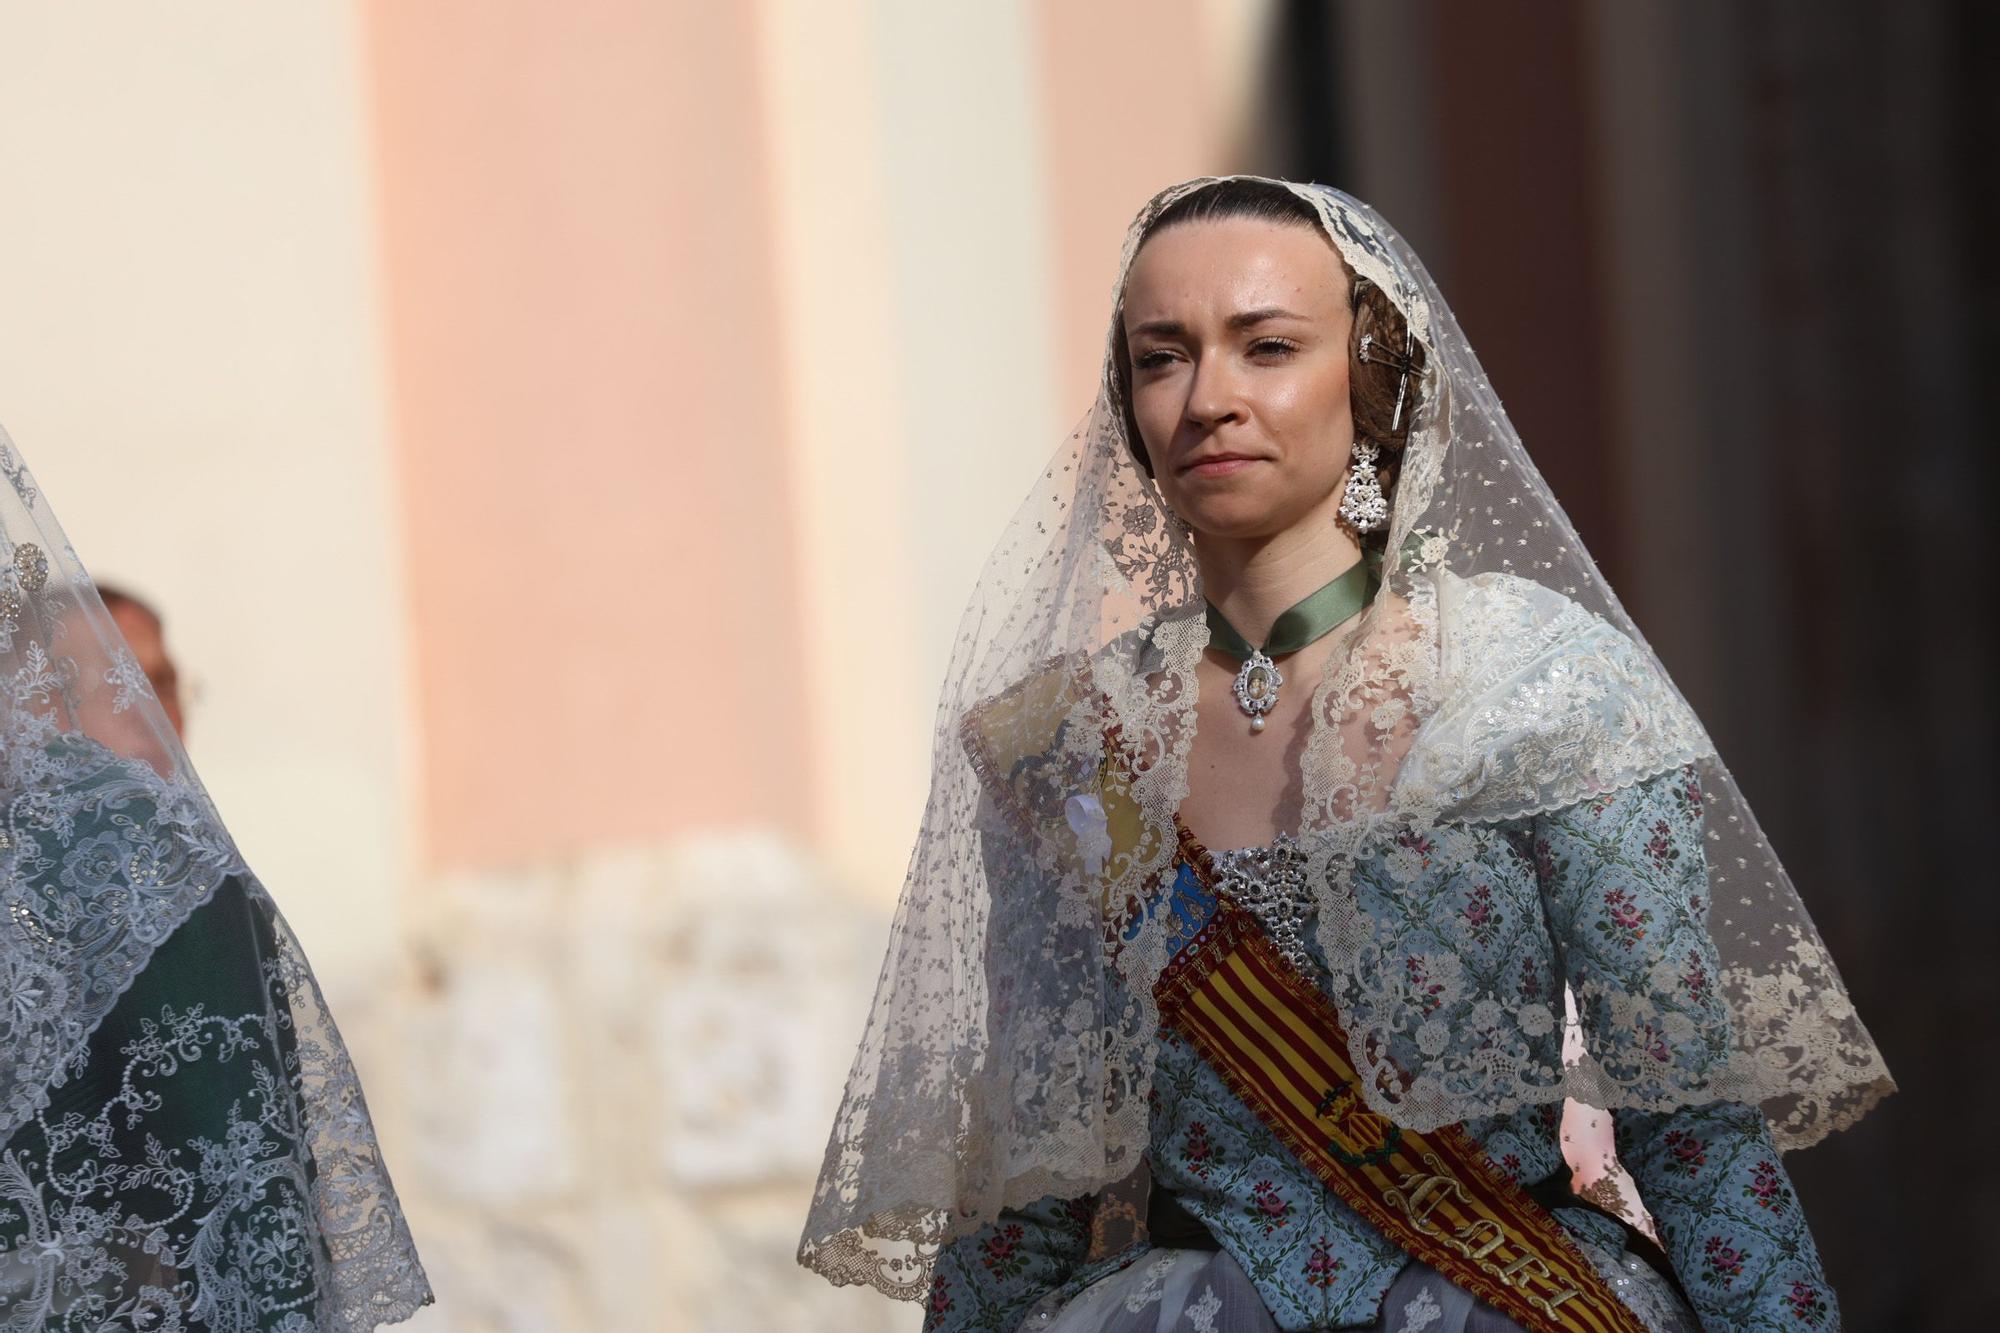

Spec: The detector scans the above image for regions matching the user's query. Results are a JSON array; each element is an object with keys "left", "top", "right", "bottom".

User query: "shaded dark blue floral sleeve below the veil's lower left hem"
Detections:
[{"left": 924, "top": 1197, "right": 1090, "bottom": 1333}]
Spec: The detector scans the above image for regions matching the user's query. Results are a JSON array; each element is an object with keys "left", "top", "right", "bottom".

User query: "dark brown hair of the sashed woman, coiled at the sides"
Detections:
[{"left": 1112, "top": 180, "right": 1424, "bottom": 542}]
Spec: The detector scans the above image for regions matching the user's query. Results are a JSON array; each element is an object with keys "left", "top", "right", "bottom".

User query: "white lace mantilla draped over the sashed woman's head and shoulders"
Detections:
[{"left": 800, "top": 180, "right": 1894, "bottom": 1299}]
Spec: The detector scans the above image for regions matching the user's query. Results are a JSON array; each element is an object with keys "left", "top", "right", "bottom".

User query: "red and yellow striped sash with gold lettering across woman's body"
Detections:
[{"left": 1154, "top": 899, "right": 1646, "bottom": 1333}]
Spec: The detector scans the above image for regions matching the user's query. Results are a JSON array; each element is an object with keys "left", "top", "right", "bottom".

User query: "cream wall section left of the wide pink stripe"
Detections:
[{"left": 0, "top": 0, "right": 410, "bottom": 1007}]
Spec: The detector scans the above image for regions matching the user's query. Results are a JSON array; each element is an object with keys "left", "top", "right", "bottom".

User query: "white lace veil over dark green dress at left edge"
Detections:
[{"left": 0, "top": 430, "right": 430, "bottom": 1333}]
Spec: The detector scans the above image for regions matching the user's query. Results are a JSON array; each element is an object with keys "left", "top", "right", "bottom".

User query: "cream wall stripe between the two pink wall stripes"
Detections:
[{"left": 764, "top": 0, "right": 1062, "bottom": 903}]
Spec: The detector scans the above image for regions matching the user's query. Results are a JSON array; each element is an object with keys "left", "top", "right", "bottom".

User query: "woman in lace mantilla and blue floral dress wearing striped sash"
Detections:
[{"left": 800, "top": 178, "right": 1892, "bottom": 1333}]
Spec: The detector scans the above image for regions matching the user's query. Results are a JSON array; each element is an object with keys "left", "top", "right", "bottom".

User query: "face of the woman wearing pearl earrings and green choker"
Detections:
[{"left": 1124, "top": 218, "right": 1354, "bottom": 538}]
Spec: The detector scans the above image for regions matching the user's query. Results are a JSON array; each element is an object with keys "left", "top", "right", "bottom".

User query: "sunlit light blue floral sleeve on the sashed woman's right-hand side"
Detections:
[{"left": 1534, "top": 771, "right": 1840, "bottom": 1331}]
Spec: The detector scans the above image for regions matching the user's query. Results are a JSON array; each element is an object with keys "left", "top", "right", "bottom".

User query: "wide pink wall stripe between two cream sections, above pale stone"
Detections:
[{"left": 364, "top": 0, "right": 808, "bottom": 869}]
